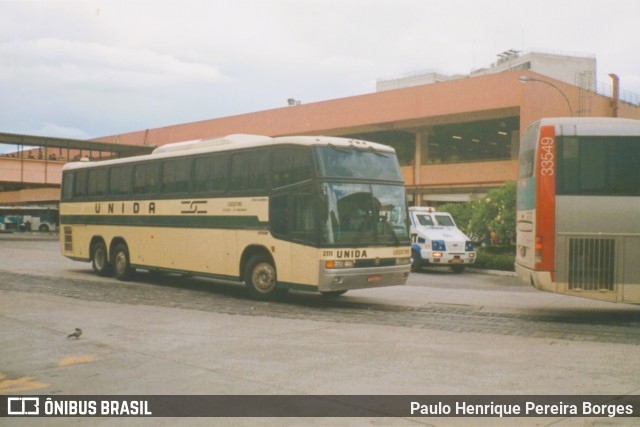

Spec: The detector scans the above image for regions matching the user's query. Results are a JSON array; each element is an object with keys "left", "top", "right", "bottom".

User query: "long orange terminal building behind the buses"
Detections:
[{"left": 0, "top": 50, "right": 640, "bottom": 205}]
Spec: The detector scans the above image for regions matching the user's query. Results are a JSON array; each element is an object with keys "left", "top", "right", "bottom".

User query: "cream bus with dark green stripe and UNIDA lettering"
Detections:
[{"left": 60, "top": 135, "right": 411, "bottom": 299}]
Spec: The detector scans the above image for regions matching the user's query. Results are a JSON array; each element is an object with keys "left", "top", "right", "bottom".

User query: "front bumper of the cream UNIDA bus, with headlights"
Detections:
[{"left": 318, "top": 265, "right": 411, "bottom": 292}]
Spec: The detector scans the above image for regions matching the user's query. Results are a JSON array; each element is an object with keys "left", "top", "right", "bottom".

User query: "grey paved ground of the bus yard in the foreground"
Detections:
[{"left": 0, "top": 233, "right": 640, "bottom": 426}]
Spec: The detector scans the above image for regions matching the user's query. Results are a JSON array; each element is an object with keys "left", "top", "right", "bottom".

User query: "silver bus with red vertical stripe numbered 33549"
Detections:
[{"left": 515, "top": 118, "right": 640, "bottom": 304}]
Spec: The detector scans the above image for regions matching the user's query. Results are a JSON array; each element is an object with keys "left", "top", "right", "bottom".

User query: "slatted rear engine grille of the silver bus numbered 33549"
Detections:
[{"left": 569, "top": 238, "right": 616, "bottom": 291}]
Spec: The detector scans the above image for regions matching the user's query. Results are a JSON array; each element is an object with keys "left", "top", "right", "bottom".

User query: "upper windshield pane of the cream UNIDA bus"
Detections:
[{"left": 316, "top": 145, "right": 402, "bottom": 181}]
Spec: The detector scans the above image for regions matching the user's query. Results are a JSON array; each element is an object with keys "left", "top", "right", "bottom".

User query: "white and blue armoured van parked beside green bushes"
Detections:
[{"left": 409, "top": 206, "right": 476, "bottom": 273}]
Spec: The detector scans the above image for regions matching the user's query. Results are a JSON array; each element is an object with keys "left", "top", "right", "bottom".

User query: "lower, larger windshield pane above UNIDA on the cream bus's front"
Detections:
[{"left": 321, "top": 183, "right": 409, "bottom": 245}]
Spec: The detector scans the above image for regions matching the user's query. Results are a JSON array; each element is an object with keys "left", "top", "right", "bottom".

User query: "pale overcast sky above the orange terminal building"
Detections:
[{"left": 0, "top": 0, "right": 640, "bottom": 139}]
